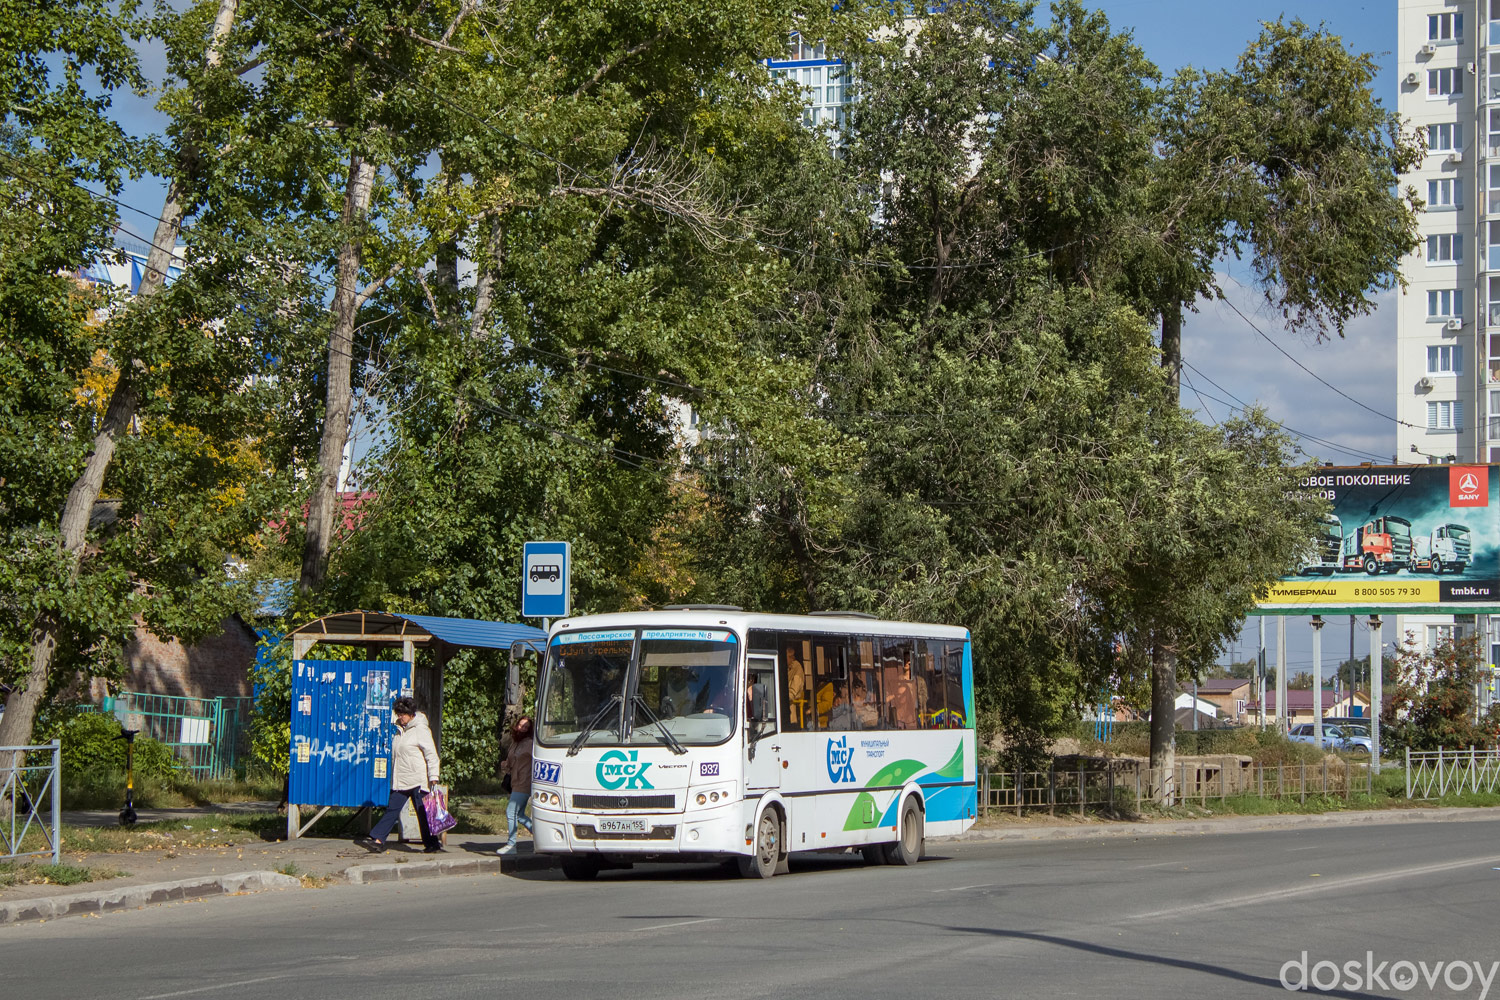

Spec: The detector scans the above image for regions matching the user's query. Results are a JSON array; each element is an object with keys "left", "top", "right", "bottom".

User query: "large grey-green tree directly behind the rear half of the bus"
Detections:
[{"left": 687, "top": 3, "right": 1317, "bottom": 777}]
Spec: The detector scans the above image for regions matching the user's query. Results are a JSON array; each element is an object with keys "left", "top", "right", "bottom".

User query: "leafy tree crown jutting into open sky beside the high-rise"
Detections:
[{"left": 1128, "top": 19, "right": 1424, "bottom": 387}]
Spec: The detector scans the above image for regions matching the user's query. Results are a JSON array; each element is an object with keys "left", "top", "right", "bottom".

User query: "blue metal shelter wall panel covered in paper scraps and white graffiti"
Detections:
[{"left": 288, "top": 660, "right": 411, "bottom": 807}]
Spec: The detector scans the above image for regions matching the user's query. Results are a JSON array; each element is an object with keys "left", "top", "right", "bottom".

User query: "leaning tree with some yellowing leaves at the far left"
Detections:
[{"left": 0, "top": 0, "right": 304, "bottom": 745}]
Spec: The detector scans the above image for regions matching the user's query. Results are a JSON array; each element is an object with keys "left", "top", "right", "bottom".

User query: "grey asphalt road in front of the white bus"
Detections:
[{"left": 0, "top": 822, "right": 1500, "bottom": 1000}]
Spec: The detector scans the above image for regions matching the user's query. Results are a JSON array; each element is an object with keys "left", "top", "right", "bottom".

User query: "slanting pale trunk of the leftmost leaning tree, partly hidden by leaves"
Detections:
[{"left": 0, "top": 0, "right": 239, "bottom": 758}]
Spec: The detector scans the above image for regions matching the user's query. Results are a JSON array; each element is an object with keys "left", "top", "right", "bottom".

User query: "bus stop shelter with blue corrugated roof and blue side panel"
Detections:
[{"left": 287, "top": 612, "right": 546, "bottom": 840}]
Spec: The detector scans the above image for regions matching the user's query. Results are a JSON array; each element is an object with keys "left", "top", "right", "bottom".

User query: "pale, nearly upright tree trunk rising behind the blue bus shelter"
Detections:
[{"left": 299, "top": 151, "right": 375, "bottom": 594}]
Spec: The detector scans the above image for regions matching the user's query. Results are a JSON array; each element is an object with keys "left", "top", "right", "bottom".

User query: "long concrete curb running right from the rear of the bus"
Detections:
[{"left": 932, "top": 807, "right": 1500, "bottom": 844}]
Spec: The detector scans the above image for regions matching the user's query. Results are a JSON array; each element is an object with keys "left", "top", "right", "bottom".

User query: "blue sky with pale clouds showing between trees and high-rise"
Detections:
[{"left": 96, "top": 0, "right": 1398, "bottom": 672}]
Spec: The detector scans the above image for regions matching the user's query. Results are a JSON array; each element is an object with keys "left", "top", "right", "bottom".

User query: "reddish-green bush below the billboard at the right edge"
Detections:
[{"left": 1380, "top": 634, "right": 1500, "bottom": 754}]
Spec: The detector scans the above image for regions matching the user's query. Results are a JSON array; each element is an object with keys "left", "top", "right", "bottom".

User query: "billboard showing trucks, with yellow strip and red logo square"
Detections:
[{"left": 1260, "top": 465, "right": 1500, "bottom": 615}]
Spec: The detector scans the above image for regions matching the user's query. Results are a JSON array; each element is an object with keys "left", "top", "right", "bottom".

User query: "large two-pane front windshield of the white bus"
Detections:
[{"left": 537, "top": 628, "right": 738, "bottom": 747}]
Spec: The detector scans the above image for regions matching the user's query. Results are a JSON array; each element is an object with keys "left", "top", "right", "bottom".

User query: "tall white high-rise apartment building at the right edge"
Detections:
[{"left": 1395, "top": 0, "right": 1500, "bottom": 665}]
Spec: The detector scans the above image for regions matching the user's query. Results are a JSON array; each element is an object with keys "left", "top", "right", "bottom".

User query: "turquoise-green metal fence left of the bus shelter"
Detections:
[{"left": 83, "top": 691, "right": 254, "bottom": 778}]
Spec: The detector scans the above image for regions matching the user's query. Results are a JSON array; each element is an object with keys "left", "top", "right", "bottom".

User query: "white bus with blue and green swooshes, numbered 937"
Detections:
[{"left": 531, "top": 606, "right": 978, "bottom": 879}]
